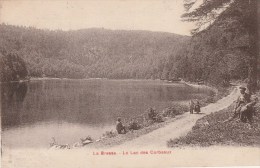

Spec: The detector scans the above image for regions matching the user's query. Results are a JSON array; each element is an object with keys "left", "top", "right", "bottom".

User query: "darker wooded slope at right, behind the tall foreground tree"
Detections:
[{"left": 166, "top": 0, "right": 259, "bottom": 85}]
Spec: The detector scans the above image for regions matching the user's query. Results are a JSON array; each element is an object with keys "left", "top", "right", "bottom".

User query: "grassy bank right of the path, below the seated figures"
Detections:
[{"left": 168, "top": 92, "right": 260, "bottom": 147}]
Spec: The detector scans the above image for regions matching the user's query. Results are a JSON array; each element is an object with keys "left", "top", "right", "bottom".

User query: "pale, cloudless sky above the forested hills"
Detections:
[{"left": 0, "top": 0, "right": 194, "bottom": 35}]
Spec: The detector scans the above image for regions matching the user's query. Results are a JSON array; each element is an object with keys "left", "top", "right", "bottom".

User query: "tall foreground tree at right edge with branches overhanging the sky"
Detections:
[{"left": 182, "top": 0, "right": 259, "bottom": 92}]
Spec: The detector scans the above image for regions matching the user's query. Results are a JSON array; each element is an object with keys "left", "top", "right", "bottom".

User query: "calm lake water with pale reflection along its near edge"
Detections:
[{"left": 1, "top": 79, "right": 212, "bottom": 148}]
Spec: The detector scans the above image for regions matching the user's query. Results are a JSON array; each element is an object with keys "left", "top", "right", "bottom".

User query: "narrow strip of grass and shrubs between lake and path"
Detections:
[{"left": 48, "top": 84, "right": 233, "bottom": 148}]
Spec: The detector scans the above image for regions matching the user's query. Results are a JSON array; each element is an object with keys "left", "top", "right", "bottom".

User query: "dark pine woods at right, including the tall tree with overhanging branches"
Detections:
[{"left": 173, "top": 0, "right": 260, "bottom": 92}]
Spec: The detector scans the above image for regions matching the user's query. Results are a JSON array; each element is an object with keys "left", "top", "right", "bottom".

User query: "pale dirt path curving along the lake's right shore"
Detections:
[{"left": 117, "top": 88, "right": 239, "bottom": 148}]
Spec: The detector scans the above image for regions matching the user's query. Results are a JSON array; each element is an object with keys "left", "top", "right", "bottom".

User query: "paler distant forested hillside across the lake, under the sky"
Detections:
[{"left": 0, "top": 24, "right": 189, "bottom": 79}]
